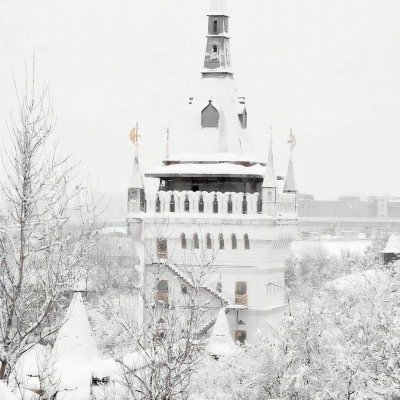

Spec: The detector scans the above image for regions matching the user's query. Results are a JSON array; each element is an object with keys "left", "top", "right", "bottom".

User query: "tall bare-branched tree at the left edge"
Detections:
[{"left": 0, "top": 63, "right": 97, "bottom": 380}]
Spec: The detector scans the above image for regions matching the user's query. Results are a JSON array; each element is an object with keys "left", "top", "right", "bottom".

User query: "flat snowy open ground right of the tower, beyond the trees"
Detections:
[{"left": 291, "top": 239, "right": 372, "bottom": 257}]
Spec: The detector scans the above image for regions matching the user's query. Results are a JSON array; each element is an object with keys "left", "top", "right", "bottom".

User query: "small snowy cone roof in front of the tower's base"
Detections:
[{"left": 207, "top": 308, "right": 237, "bottom": 357}]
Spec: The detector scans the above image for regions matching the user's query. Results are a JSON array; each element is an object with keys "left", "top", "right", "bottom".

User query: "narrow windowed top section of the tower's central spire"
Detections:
[{"left": 203, "top": 0, "right": 231, "bottom": 75}]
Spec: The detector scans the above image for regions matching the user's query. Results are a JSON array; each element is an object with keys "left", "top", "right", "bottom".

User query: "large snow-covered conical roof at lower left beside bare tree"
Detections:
[{"left": 51, "top": 293, "right": 102, "bottom": 400}]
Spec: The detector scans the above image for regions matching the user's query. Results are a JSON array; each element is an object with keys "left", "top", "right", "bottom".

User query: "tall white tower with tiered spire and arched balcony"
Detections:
[{"left": 127, "top": 0, "right": 298, "bottom": 342}]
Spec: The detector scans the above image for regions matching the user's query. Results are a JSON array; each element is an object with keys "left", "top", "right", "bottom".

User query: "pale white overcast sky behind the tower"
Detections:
[{"left": 0, "top": 0, "right": 400, "bottom": 198}]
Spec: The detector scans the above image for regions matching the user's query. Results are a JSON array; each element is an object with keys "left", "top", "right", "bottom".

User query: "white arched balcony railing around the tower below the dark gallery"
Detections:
[{"left": 146, "top": 190, "right": 296, "bottom": 219}]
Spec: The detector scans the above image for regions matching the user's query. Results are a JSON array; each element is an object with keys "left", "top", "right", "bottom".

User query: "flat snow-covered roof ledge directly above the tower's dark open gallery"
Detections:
[{"left": 146, "top": 163, "right": 265, "bottom": 178}]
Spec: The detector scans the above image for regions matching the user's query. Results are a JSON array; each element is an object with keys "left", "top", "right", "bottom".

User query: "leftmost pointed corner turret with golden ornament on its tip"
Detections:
[{"left": 128, "top": 125, "right": 144, "bottom": 213}]
